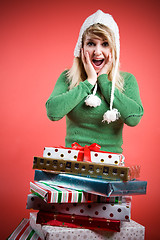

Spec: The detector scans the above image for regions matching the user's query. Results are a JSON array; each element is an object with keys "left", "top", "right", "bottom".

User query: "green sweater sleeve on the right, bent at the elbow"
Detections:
[{"left": 98, "top": 73, "right": 143, "bottom": 126}]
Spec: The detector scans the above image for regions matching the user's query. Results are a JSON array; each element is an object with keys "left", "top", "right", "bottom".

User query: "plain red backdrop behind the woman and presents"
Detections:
[{"left": 0, "top": 0, "right": 160, "bottom": 239}]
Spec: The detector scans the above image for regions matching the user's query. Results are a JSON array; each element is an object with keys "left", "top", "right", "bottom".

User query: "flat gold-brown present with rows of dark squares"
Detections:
[{"left": 33, "top": 157, "right": 140, "bottom": 181}]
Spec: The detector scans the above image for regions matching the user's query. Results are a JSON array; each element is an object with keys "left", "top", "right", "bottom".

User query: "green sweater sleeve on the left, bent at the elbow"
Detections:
[{"left": 46, "top": 71, "right": 94, "bottom": 121}]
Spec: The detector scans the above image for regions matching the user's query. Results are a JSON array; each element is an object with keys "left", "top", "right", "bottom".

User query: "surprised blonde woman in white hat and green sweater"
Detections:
[{"left": 46, "top": 10, "right": 143, "bottom": 153}]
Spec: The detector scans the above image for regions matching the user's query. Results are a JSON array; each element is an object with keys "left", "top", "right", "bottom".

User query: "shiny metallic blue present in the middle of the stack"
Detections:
[{"left": 34, "top": 170, "right": 147, "bottom": 197}]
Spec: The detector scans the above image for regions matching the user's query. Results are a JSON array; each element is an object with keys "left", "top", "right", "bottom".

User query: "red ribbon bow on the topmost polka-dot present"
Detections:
[{"left": 72, "top": 142, "right": 101, "bottom": 162}]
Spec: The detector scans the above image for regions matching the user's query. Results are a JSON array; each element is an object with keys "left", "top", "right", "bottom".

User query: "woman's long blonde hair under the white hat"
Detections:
[{"left": 67, "top": 23, "right": 124, "bottom": 92}]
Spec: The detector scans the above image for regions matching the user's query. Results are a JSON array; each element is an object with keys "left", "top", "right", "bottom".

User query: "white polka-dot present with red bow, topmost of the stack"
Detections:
[{"left": 43, "top": 142, "right": 125, "bottom": 165}]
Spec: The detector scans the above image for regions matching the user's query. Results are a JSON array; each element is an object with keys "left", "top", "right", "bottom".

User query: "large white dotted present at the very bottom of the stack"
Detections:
[{"left": 30, "top": 213, "right": 145, "bottom": 240}]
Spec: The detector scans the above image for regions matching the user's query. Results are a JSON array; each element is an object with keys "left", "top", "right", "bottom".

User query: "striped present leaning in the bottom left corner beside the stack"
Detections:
[{"left": 7, "top": 219, "right": 43, "bottom": 240}]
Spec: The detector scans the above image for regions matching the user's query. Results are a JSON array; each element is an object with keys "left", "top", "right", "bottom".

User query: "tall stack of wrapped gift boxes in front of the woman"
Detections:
[{"left": 8, "top": 143, "right": 147, "bottom": 240}]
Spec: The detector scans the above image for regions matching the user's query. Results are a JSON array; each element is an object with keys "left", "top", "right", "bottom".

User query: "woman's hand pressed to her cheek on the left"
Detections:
[{"left": 81, "top": 48, "right": 97, "bottom": 85}]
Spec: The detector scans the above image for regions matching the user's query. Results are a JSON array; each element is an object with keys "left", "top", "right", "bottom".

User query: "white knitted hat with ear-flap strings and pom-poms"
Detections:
[{"left": 74, "top": 10, "right": 120, "bottom": 123}]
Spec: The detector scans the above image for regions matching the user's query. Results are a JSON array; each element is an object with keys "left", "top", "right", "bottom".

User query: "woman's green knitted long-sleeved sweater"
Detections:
[{"left": 46, "top": 71, "right": 143, "bottom": 153}]
